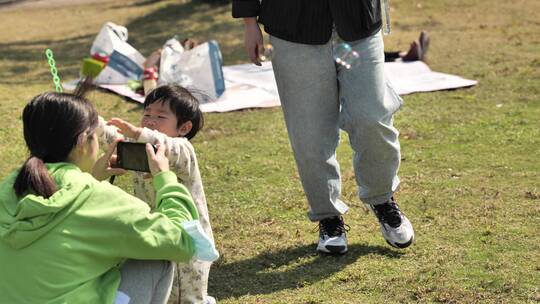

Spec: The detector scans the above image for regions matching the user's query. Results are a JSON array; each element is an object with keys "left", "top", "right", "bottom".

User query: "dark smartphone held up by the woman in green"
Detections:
[{"left": 116, "top": 141, "right": 157, "bottom": 172}]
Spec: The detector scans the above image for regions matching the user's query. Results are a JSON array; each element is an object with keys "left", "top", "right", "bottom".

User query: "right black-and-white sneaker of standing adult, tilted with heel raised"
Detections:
[{"left": 366, "top": 197, "right": 414, "bottom": 248}]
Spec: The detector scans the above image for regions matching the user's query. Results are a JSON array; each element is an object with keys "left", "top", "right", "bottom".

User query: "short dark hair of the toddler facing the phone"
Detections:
[{"left": 144, "top": 84, "right": 204, "bottom": 139}]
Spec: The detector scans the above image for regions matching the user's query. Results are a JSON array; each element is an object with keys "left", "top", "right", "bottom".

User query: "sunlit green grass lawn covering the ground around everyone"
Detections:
[{"left": 0, "top": 0, "right": 540, "bottom": 303}]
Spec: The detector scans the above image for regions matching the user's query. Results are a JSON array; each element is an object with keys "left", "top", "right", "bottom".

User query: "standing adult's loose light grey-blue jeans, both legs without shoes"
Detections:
[{"left": 270, "top": 33, "right": 402, "bottom": 221}]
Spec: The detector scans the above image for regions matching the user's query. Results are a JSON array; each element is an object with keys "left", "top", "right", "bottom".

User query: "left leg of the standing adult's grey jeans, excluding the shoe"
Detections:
[{"left": 270, "top": 37, "right": 348, "bottom": 221}]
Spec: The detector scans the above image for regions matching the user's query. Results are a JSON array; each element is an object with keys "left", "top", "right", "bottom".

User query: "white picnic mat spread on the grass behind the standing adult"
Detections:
[{"left": 65, "top": 61, "right": 478, "bottom": 112}]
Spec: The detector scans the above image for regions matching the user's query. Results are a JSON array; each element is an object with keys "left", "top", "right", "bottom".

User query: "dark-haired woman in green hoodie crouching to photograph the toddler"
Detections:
[{"left": 0, "top": 93, "right": 202, "bottom": 304}]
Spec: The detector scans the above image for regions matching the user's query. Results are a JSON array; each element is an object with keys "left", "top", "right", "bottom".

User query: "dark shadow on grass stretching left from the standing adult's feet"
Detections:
[{"left": 209, "top": 244, "right": 401, "bottom": 300}]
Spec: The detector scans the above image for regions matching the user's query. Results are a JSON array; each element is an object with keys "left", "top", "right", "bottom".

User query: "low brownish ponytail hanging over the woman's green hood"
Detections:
[{"left": 13, "top": 156, "right": 56, "bottom": 198}]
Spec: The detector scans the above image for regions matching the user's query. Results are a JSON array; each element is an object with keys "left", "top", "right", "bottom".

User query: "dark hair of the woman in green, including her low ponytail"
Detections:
[{"left": 13, "top": 93, "right": 98, "bottom": 198}]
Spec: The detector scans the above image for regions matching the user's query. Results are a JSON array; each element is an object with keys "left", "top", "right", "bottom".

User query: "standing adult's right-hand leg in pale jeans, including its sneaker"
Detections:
[{"left": 339, "top": 33, "right": 414, "bottom": 248}]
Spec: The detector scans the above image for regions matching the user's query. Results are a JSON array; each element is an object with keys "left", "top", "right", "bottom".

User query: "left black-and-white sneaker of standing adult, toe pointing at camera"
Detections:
[{"left": 317, "top": 216, "right": 349, "bottom": 254}]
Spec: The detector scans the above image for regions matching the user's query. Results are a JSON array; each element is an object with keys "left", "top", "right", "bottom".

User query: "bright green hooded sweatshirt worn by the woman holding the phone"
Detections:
[{"left": 0, "top": 163, "right": 198, "bottom": 304}]
